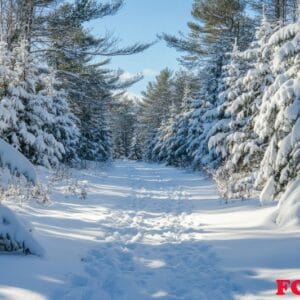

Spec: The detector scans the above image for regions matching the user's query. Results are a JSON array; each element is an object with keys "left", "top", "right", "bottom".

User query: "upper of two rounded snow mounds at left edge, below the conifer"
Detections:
[{"left": 0, "top": 139, "right": 37, "bottom": 184}]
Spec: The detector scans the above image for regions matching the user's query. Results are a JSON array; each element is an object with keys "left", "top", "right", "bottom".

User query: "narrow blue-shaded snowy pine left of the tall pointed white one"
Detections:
[{"left": 183, "top": 36, "right": 239, "bottom": 169}]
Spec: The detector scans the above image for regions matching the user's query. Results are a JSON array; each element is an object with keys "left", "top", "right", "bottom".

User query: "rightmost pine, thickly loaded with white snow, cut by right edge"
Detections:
[{"left": 254, "top": 18, "right": 300, "bottom": 203}]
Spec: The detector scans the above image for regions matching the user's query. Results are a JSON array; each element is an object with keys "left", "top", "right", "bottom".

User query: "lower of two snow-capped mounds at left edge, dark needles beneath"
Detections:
[{"left": 0, "top": 204, "right": 44, "bottom": 256}]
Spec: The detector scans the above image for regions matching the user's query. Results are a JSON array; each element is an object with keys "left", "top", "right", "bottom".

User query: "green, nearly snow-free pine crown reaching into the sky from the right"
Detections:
[{"left": 162, "top": 0, "right": 253, "bottom": 68}]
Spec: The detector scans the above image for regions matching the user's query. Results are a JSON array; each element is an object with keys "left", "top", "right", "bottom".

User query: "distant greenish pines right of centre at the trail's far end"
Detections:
[{"left": 133, "top": 69, "right": 198, "bottom": 161}]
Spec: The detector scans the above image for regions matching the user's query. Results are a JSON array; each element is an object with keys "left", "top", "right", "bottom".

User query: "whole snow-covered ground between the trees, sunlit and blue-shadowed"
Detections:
[{"left": 0, "top": 161, "right": 300, "bottom": 300}]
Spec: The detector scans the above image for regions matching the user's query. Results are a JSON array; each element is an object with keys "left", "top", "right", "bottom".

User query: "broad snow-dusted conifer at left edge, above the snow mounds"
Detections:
[{"left": 0, "top": 40, "right": 77, "bottom": 167}]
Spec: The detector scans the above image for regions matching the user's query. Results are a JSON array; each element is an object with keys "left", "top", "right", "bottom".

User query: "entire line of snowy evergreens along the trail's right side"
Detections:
[{"left": 132, "top": 0, "right": 300, "bottom": 206}]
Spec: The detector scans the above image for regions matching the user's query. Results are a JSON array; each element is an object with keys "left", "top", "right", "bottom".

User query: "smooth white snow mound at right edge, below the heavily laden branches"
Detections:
[{"left": 275, "top": 178, "right": 300, "bottom": 225}]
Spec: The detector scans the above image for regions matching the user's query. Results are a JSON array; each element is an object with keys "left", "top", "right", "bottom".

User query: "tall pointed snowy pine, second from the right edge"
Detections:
[{"left": 215, "top": 13, "right": 273, "bottom": 197}]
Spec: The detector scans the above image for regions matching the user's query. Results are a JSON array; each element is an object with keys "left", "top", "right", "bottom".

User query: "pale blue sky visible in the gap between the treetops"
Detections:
[{"left": 89, "top": 0, "right": 193, "bottom": 94}]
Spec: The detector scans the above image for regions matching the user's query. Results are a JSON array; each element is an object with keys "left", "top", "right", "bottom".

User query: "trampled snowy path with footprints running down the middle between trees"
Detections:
[{"left": 56, "top": 161, "right": 234, "bottom": 300}]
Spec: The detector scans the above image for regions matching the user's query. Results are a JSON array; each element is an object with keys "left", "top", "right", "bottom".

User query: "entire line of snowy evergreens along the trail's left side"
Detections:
[{"left": 0, "top": 0, "right": 149, "bottom": 167}]
